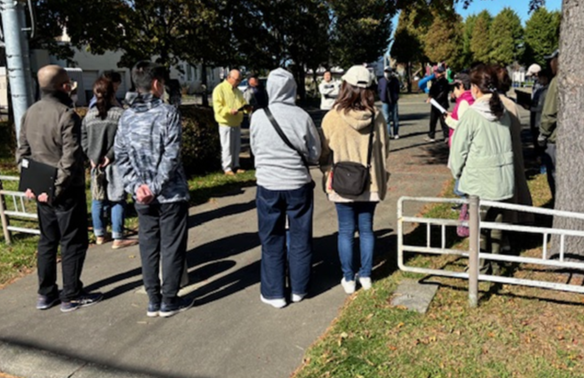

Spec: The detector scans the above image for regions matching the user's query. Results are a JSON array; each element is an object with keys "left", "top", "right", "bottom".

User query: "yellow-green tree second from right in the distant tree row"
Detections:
[{"left": 489, "top": 8, "right": 524, "bottom": 66}]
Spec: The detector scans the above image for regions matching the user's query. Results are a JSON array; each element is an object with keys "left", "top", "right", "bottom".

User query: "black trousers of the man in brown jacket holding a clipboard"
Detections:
[{"left": 37, "top": 187, "right": 88, "bottom": 302}]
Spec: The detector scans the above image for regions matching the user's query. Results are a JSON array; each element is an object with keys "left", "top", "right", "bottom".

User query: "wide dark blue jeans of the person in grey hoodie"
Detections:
[{"left": 256, "top": 183, "right": 314, "bottom": 299}]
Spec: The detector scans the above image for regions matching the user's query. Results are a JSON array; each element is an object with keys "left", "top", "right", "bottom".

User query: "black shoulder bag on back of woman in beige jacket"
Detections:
[{"left": 332, "top": 114, "right": 375, "bottom": 196}]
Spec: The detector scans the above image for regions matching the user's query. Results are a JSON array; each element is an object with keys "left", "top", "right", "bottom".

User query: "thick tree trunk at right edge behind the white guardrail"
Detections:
[{"left": 552, "top": 0, "right": 584, "bottom": 260}]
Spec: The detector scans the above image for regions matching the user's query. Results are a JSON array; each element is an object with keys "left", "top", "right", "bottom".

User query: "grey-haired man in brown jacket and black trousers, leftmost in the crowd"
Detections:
[{"left": 16, "top": 65, "right": 103, "bottom": 312}]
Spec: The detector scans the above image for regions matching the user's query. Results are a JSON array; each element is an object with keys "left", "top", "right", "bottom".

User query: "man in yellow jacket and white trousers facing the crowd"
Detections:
[{"left": 213, "top": 70, "right": 249, "bottom": 176}]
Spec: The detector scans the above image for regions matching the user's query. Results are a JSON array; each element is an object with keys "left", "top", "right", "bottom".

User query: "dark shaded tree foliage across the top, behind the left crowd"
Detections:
[{"left": 33, "top": 0, "right": 396, "bottom": 99}]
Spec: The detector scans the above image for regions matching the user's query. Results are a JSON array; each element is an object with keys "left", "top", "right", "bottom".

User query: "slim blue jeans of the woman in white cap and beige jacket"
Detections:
[{"left": 335, "top": 202, "right": 377, "bottom": 281}]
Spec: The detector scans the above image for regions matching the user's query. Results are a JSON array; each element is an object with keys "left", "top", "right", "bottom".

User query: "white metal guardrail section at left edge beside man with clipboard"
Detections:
[{"left": 0, "top": 176, "right": 41, "bottom": 244}]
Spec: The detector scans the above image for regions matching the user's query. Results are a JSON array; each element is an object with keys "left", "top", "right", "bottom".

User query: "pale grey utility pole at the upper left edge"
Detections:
[{"left": 0, "top": 0, "right": 32, "bottom": 146}]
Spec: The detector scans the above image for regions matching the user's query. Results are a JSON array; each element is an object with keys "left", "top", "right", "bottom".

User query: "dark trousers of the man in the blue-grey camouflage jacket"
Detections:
[{"left": 135, "top": 201, "right": 188, "bottom": 304}]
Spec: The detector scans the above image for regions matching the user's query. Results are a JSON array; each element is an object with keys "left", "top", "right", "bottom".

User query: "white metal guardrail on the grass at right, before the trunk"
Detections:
[{"left": 397, "top": 196, "right": 584, "bottom": 307}]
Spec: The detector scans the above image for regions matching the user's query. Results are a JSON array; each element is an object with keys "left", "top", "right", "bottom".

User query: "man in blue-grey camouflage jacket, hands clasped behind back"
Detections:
[{"left": 114, "top": 61, "right": 193, "bottom": 317}]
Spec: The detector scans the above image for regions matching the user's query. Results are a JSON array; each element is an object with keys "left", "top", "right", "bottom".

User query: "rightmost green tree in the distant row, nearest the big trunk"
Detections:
[{"left": 523, "top": 8, "right": 561, "bottom": 66}]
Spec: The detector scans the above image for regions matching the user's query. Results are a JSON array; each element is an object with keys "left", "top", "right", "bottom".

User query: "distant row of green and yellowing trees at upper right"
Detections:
[{"left": 391, "top": 7, "right": 561, "bottom": 75}]
